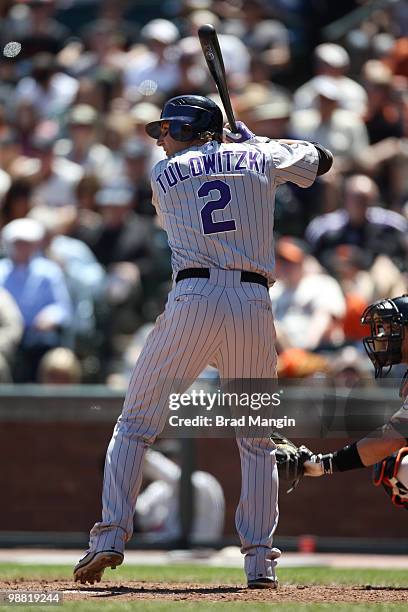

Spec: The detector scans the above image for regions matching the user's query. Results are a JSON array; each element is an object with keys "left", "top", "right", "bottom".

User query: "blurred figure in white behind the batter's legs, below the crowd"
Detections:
[{"left": 134, "top": 449, "right": 225, "bottom": 543}]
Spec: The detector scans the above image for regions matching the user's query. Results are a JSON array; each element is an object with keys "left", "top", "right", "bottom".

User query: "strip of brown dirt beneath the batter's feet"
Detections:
[{"left": 0, "top": 579, "right": 408, "bottom": 603}]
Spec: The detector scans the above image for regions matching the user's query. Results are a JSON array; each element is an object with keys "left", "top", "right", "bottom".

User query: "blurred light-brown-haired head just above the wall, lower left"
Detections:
[{"left": 38, "top": 347, "right": 81, "bottom": 385}]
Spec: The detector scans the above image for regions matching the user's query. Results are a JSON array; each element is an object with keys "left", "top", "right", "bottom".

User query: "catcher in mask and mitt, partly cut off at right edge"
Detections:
[{"left": 272, "top": 295, "right": 408, "bottom": 510}]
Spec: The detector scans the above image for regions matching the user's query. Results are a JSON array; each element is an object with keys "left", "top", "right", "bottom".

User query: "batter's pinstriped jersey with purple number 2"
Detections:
[{"left": 151, "top": 138, "right": 318, "bottom": 284}]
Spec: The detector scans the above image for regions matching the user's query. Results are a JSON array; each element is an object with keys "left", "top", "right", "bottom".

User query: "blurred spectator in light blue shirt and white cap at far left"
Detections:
[{"left": 0, "top": 219, "right": 72, "bottom": 382}]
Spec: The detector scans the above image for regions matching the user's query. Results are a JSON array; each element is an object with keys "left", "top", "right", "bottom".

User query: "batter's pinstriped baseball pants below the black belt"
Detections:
[{"left": 90, "top": 269, "right": 280, "bottom": 579}]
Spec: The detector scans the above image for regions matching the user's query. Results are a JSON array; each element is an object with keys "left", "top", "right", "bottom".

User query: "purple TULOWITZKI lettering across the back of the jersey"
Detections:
[{"left": 156, "top": 150, "right": 266, "bottom": 193}]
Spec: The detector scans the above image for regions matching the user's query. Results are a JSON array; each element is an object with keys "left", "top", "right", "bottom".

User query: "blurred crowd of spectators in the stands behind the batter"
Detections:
[{"left": 0, "top": 0, "right": 408, "bottom": 386}]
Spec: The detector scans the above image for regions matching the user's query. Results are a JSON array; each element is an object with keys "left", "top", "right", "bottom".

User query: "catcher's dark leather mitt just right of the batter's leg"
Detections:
[{"left": 271, "top": 431, "right": 313, "bottom": 493}]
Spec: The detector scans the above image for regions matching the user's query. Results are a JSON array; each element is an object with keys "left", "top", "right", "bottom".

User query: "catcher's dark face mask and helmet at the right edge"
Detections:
[{"left": 361, "top": 295, "right": 408, "bottom": 378}]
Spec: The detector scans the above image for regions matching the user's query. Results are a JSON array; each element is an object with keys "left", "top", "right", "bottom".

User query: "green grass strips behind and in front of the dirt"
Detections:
[{"left": 0, "top": 564, "right": 408, "bottom": 612}]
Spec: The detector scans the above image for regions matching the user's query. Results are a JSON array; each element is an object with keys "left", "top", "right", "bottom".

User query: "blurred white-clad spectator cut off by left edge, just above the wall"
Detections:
[{"left": 0, "top": 287, "right": 23, "bottom": 383}]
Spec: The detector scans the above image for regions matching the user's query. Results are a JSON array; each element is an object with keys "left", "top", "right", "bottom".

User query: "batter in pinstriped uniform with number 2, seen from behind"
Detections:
[{"left": 74, "top": 96, "right": 332, "bottom": 588}]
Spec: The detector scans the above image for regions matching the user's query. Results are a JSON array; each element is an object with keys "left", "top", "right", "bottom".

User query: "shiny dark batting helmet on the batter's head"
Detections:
[{"left": 146, "top": 96, "right": 223, "bottom": 142}]
